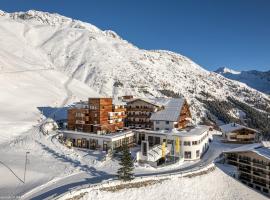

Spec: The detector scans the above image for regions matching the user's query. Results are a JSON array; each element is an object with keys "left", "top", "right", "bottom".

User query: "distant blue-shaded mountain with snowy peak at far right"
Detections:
[{"left": 215, "top": 67, "right": 270, "bottom": 94}]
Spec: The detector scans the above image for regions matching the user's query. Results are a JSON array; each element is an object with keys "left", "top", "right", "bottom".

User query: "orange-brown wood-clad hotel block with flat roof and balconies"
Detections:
[{"left": 68, "top": 98, "right": 126, "bottom": 134}]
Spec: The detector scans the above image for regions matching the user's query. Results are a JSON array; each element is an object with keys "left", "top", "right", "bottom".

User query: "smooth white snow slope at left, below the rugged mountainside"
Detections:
[{"left": 0, "top": 10, "right": 98, "bottom": 142}]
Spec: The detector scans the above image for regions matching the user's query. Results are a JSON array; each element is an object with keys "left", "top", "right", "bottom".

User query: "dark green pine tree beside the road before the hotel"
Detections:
[{"left": 117, "top": 145, "right": 134, "bottom": 181}]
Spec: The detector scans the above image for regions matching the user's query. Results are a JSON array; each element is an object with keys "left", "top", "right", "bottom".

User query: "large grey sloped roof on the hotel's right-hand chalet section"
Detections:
[{"left": 150, "top": 98, "right": 185, "bottom": 122}]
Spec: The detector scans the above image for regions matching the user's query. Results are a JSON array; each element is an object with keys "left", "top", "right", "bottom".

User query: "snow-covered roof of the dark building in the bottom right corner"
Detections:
[{"left": 224, "top": 142, "right": 270, "bottom": 159}]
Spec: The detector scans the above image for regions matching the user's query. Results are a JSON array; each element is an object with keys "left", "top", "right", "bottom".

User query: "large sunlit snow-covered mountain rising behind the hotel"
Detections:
[{"left": 0, "top": 11, "right": 270, "bottom": 140}]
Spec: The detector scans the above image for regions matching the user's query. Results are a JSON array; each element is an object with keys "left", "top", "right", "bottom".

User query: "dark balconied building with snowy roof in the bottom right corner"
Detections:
[{"left": 223, "top": 142, "right": 270, "bottom": 196}]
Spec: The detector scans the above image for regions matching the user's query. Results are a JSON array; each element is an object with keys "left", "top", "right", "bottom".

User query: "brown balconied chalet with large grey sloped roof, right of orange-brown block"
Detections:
[{"left": 126, "top": 98, "right": 191, "bottom": 130}]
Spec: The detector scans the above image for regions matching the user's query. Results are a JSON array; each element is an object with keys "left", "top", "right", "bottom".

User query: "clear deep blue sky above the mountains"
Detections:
[{"left": 0, "top": 0, "right": 270, "bottom": 71}]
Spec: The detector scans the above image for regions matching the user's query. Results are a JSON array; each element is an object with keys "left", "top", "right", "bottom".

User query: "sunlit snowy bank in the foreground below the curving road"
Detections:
[{"left": 58, "top": 164, "right": 268, "bottom": 200}]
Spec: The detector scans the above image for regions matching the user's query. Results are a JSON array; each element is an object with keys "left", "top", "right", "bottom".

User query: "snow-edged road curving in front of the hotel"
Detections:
[{"left": 22, "top": 136, "right": 239, "bottom": 200}]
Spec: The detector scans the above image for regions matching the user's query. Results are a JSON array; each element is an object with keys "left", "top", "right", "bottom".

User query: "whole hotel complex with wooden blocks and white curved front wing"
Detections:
[{"left": 62, "top": 96, "right": 215, "bottom": 166}]
